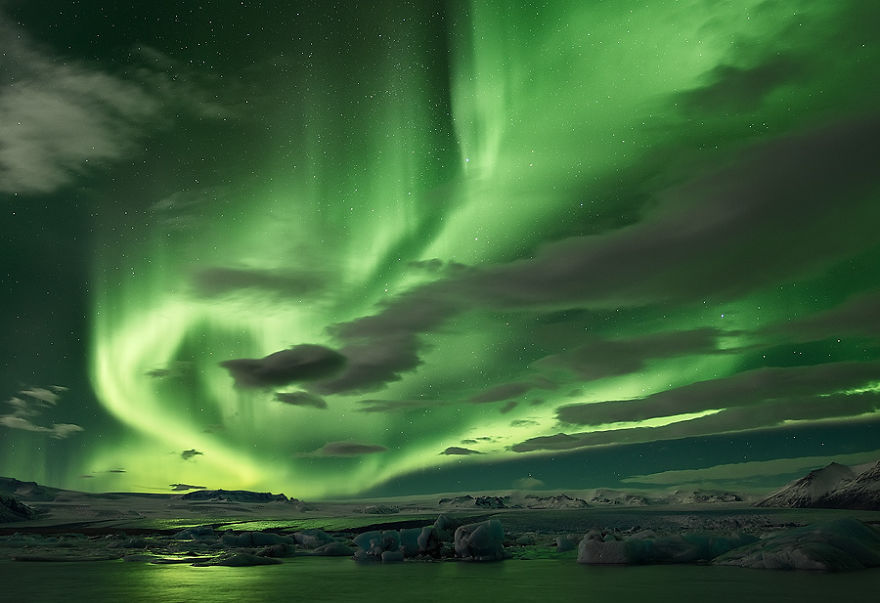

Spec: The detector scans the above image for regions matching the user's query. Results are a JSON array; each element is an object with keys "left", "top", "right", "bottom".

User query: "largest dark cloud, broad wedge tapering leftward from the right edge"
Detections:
[{"left": 460, "top": 117, "right": 880, "bottom": 307}]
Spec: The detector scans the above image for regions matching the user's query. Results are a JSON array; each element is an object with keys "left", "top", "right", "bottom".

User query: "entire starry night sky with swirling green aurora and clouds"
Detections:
[{"left": 0, "top": 0, "right": 880, "bottom": 498}]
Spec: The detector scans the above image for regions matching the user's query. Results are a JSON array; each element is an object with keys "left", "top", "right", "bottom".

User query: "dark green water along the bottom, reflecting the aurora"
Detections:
[{"left": 0, "top": 557, "right": 880, "bottom": 603}]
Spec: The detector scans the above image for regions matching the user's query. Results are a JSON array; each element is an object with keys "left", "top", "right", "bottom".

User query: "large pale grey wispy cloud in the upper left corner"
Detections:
[{"left": 0, "top": 15, "right": 225, "bottom": 194}]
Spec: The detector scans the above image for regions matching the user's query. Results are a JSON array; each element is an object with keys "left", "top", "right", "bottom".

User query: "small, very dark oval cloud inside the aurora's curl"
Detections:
[{"left": 220, "top": 344, "right": 345, "bottom": 388}]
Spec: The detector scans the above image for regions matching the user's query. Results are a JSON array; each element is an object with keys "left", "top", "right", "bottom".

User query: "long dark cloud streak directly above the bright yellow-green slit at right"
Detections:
[{"left": 556, "top": 362, "right": 880, "bottom": 425}]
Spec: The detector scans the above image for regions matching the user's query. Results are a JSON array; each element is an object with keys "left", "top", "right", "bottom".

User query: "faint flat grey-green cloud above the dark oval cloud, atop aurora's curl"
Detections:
[{"left": 192, "top": 267, "right": 324, "bottom": 298}]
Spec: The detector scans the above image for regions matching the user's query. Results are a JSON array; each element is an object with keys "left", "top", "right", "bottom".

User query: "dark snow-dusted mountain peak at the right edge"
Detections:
[{"left": 755, "top": 462, "right": 880, "bottom": 510}]
